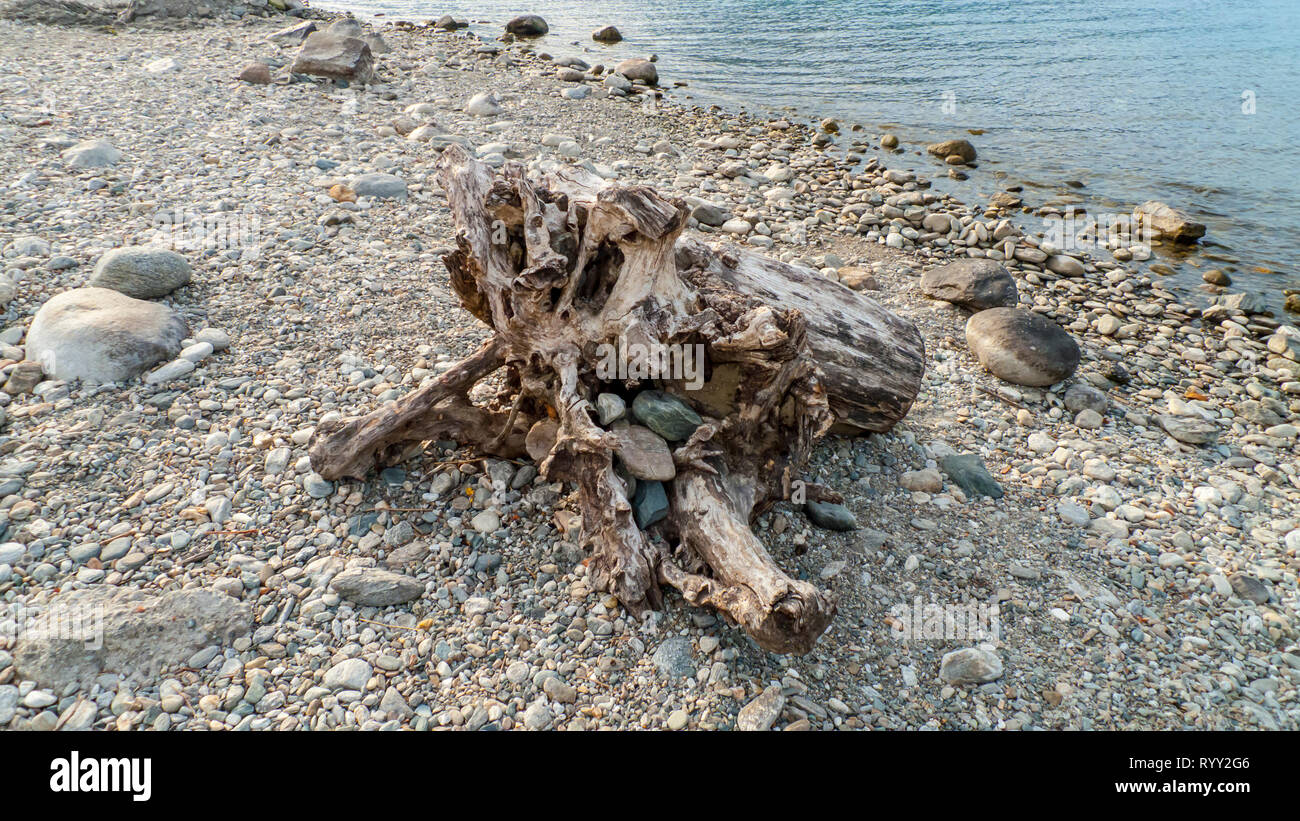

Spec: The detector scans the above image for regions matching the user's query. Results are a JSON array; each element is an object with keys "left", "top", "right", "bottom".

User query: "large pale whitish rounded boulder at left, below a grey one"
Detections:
[{"left": 27, "top": 288, "right": 190, "bottom": 382}]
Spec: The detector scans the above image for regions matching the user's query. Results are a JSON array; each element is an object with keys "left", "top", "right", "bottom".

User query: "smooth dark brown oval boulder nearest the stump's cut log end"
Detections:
[{"left": 966, "top": 308, "right": 1079, "bottom": 387}]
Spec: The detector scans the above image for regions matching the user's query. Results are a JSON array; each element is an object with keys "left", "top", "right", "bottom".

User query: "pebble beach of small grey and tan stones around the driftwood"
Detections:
[{"left": 0, "top": 11, "right": 1300, "bottom": 729}]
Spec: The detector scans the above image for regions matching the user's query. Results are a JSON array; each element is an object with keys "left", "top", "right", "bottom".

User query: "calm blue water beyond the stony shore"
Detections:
[{"left": 324, "top": 0, "right": 1300, "bottom": 314}]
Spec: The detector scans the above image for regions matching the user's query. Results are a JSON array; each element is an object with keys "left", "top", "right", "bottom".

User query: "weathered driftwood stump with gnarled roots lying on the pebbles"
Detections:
[{"left": 311, "top": 145, "right": 924, "bottom": 653}]
